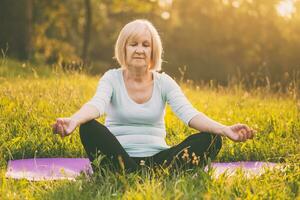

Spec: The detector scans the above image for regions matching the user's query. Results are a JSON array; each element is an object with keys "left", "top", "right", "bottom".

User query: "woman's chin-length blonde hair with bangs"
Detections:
[{"left": 115, "top": 19, "right": 163, "bottom": 71}]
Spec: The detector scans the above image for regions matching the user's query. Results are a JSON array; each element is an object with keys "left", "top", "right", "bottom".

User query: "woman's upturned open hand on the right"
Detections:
[{"left": 222, "top": 124, "right": 256, "bottom": 142}]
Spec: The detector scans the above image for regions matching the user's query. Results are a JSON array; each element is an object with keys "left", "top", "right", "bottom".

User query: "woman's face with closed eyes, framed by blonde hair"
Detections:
[{"left": 126, "top": 29, "right": 152, "bottom": 68}]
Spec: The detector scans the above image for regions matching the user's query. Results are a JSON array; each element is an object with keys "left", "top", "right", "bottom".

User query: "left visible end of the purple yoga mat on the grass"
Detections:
[{"left": 6, "top": 158, "right": 93, "bottom": 181}]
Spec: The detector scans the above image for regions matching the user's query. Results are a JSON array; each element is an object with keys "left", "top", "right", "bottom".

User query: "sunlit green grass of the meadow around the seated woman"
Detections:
[{"left": 0, "top": 60, "right": 300, "bottom": 199}]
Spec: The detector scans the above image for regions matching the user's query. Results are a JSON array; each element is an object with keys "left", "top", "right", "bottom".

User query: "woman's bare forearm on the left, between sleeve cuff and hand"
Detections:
[{"left": 71, "top": 104, "right": 99, "bottom": 126}]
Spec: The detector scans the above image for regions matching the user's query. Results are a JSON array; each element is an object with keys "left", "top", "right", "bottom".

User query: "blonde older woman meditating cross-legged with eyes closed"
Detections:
[{"left": 53, "top": 20, "right": 254, "bottom": 171}]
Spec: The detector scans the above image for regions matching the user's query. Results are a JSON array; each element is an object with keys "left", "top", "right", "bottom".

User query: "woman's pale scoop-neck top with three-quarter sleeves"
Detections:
[{"left": 87, "top": 68, "right": 199, "bottom": 157}]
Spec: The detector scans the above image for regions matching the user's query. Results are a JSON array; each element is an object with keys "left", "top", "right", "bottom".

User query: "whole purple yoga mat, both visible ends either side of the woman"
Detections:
[{"left": 6, "top": 158, "right": 279, "bottom": 181}]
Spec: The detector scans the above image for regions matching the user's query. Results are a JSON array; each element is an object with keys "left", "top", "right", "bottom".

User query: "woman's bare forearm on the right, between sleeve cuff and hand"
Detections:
[{"left": 189, "top": 112, "right": 227, "bottom": 135}]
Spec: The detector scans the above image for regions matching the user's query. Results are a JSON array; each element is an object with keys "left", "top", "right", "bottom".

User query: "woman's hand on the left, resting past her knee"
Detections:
[{"left": 52, "top": 118, "right": 78, "bottom": 137}]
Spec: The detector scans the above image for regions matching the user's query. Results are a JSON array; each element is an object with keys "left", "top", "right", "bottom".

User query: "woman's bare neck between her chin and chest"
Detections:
[{"left": 124, "top": 67, "right": 152, "bottom": 82}]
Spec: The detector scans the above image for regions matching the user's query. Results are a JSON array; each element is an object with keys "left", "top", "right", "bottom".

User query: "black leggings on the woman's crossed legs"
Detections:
[{"left": 79, "top": 120, "right": 222, "bottom": 172}]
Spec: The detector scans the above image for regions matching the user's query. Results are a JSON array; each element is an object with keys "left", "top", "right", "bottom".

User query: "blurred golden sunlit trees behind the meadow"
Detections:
[{"left": 0, "top": 0, "right": 300, "bottom": 90}]
